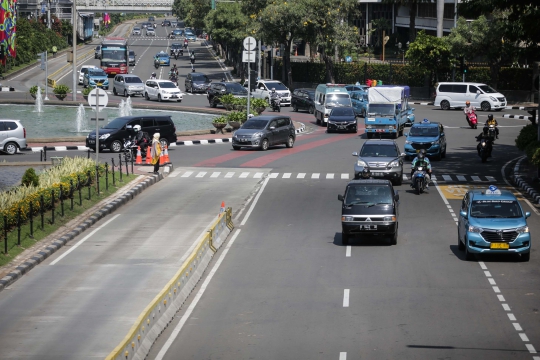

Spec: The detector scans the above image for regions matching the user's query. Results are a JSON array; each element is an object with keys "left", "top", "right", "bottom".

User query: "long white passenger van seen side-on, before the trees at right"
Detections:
[{"left": 434, "top": 82, "right": 506, "bottom": 111}]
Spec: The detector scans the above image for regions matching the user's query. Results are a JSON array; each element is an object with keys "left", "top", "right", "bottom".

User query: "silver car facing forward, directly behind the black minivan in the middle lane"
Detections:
[{"left": 353, "top": 139, "right": 405, "bottom": 185}]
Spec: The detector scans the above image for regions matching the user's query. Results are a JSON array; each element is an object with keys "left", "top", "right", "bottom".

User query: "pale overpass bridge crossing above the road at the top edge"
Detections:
[{"left": 75, "top": 0, "right": 174, "bottom": 13}]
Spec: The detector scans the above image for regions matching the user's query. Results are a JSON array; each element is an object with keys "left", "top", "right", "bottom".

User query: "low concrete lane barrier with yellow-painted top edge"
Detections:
[{"left": 105, "top": 207, "right": 234, "bottom": 360}]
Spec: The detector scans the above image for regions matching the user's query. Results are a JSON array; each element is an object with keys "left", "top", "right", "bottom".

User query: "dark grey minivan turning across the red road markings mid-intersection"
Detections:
[{"left": 232, "top": 115, "right": 296, "bottom": 151}]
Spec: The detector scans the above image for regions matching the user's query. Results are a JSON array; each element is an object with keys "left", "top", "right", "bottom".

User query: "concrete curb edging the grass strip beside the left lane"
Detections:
[{"left": 0, "top": 165, "right": 172, "bottom": 291}]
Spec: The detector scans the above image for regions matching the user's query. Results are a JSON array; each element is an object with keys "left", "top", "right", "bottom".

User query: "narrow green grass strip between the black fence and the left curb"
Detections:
[{"left": 0, "top": 173, "right": 139, "bottom": 266}]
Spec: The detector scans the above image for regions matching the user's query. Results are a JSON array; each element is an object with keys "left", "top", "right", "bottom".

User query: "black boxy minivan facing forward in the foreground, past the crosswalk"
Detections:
[{"left": 338, "top": 180, "right": 399, "bottom": 245}]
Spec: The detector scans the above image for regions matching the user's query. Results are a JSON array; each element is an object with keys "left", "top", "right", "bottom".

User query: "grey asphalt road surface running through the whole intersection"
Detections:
[{"left": 0, "top": 18, "right": 540, "bottom": 360}]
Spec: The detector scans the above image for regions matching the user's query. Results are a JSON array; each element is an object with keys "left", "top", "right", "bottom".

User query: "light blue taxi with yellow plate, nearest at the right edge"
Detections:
[{"left": 458, "top": 185, "right": 531, "bottom": 261}]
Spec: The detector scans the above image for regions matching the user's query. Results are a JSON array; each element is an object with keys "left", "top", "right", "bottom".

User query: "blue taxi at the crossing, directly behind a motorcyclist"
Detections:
[{"left": 403, "top": 119, "right": 446, "bottom": 160}]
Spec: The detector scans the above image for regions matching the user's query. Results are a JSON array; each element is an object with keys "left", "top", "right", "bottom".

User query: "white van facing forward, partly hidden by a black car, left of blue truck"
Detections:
[{"left": 315, "top": 84, "right": 352, "bottom": 126}]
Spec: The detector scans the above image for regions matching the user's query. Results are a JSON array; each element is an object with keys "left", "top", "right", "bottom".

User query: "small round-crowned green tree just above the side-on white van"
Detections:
[{"left": 405, "top": 30, "right": 451, "bottom": 85}]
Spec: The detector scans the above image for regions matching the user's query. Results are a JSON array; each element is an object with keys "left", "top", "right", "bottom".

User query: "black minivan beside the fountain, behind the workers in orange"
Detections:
[{"left": 86, "top": 115, "right": 176, "bottom": 152}]
